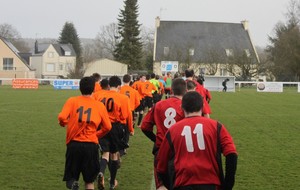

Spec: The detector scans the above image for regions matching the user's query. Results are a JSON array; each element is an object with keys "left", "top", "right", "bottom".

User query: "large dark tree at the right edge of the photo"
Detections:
[{"left": 266, "top": 0, "right": 300, "bottom": 81}]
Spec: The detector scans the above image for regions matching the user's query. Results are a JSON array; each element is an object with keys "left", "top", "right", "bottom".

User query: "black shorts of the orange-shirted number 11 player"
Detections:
[{"left": 63, "top": 141, "right": 100, "bottom": 183}]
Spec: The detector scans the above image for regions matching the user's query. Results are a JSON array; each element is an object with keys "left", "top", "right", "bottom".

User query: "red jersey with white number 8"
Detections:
[{"left": 141, "top": 97, "right": 184, "bottom": 148}]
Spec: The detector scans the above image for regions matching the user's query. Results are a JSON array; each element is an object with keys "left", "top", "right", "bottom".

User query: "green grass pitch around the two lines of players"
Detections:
[{"left": 0, "top": 86, "right": 300, "bottom": 190}]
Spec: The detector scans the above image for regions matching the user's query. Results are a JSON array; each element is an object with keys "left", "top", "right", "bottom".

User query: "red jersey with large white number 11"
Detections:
[{"left": 157, "top": 116, "right": 236, "bottom": 187}]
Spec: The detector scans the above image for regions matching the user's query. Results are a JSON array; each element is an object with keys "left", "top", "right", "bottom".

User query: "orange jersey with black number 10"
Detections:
[{"left": 94, "top": 90, "right": 133, "bottom": 132}]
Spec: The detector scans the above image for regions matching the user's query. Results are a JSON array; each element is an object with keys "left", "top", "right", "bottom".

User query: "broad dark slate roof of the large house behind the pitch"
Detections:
[{"left": 155, "top": 21, "right": 258, "bottom": 62}]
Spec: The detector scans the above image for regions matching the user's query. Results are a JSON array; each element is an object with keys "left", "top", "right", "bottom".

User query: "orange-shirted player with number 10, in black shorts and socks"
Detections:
[{"left": 95, "top": 76, "right": 134, "bottom": 189}]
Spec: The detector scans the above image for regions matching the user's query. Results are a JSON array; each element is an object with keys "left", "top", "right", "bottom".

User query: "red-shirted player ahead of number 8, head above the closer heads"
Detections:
[{"left": 185, "top": 69, "right": 211, "bottom": 118}]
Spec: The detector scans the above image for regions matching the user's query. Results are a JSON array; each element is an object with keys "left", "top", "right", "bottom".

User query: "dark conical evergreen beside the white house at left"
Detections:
[{"left": 58, "top": 22, "right": 84, "bottom": 78}]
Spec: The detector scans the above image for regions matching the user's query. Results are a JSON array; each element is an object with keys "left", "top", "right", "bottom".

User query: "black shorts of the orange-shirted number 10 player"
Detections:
[{"left": 99, "top": 123, "right": 129, "bottom": 153}]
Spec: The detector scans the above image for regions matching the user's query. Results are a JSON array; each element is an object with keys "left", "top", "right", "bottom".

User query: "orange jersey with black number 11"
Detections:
[{"left": 58, "top": 96, "right": 111, "bottom": 144}]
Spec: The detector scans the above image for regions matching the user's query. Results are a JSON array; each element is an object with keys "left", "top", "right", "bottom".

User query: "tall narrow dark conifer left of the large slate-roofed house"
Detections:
[{"left": 114, "top": 0, "right": 143, "bottom": 70}]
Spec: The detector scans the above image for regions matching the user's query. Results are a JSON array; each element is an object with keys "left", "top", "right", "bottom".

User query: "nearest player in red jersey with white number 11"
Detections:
[{"left": 157, "top": 91, "right": 237, "bottom": 190}]
